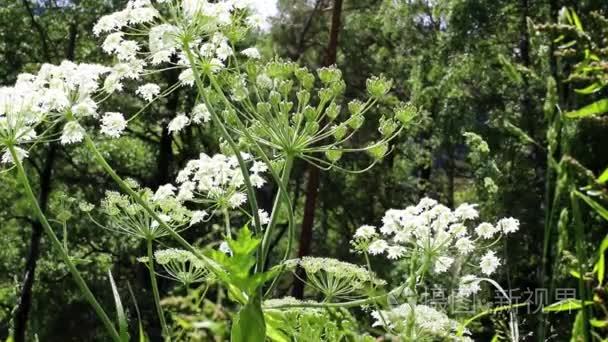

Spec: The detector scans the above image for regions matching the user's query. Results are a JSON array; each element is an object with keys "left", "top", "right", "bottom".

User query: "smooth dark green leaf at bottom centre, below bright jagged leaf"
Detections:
[{"left": 230, "top": 296, "right": 266, "bottom": 342}]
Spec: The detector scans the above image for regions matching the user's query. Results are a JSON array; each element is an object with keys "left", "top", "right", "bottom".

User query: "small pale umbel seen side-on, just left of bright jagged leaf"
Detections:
[{"left": 138, "top": 248, "right": 213, "bottom": 286}]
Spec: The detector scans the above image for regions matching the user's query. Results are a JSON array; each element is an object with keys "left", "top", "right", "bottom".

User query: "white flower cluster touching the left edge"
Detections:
[{"left": 0, "top": 61, "right": 137, "bottom": 162}]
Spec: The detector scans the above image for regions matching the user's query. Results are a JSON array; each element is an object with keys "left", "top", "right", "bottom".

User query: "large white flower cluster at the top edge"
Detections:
[{"left": 93, "top": 0, "right": 260, "bottom": 132}]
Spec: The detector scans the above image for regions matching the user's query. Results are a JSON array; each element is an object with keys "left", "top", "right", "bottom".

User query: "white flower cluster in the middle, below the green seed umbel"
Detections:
[{"left": 172, "top": 153, "right": 267, "bottom": 209}]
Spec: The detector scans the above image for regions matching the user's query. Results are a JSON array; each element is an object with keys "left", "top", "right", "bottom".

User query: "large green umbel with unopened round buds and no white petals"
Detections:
[{"left": 207, "top": 61, "right": 416, "bottom": 169}]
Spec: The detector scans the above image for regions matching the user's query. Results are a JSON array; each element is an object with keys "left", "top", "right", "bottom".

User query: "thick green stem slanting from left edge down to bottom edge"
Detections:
[{"left": 8, "top": 146, "right": 120, "bottom": 342}]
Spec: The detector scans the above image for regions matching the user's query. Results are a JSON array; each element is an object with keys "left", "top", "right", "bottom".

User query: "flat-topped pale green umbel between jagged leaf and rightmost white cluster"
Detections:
[{"left": 285, "top": 257, "right": 386, "bottom": 301}]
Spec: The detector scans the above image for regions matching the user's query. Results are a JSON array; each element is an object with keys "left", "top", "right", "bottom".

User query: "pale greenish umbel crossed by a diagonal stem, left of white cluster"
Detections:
[{"left": 88, "top": 180, "right": 206, "bottom": 240}]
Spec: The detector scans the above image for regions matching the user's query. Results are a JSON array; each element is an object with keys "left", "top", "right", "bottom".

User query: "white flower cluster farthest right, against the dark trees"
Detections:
[{"left": 352, "top": 198, "right": 519, "bottom": 294}]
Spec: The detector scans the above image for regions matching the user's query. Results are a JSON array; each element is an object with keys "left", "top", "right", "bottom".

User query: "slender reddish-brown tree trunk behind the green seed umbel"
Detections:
[{"left": 293, "top": 0, "right": 342, "bottom": 298}]
